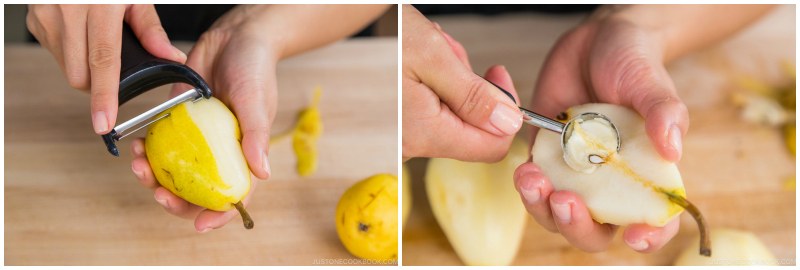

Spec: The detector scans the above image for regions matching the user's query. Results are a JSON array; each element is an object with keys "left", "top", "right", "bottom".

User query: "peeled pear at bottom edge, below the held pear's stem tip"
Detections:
[{"left": 675, "top": 229, "right": 778, "bottom": 266}]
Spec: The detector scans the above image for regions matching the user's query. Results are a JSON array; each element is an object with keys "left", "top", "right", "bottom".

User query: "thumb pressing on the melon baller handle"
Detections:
[{"left": 415, "top": 37, "right": 522, "bottom": 136}]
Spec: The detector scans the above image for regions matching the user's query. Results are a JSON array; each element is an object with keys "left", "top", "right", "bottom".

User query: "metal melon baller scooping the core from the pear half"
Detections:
[{"left": 489, "top": 82, "right": 622, "bottom": 164}]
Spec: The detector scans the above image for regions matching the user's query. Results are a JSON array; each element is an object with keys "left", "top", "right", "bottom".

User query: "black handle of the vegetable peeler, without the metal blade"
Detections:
[{"left": 102, "top": 23, "right": 216, "bottom": 156}]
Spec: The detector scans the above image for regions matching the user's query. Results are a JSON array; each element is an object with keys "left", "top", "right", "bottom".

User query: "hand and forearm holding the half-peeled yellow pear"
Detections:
[{"left": 131, "top": 5, "right": 388, "bottom": 232}]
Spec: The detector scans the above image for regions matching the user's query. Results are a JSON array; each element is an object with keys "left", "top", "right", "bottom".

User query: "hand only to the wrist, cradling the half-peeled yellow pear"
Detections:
[{"left": 131, "top": 4, "right": 277, "bottom": 232}]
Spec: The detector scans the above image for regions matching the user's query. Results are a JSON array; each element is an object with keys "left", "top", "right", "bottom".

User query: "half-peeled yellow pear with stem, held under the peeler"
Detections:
[{"left": 145, "top": 97, "right": 253, "bottom": 229}]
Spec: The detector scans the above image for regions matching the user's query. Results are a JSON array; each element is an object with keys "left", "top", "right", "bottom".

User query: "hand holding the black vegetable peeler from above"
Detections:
[{"left": 27, "top": 5, "right": 186, "bottom": 135}]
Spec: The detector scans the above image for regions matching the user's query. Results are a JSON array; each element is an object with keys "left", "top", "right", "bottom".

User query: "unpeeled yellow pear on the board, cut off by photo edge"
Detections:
[{"left": 336, "top": 174, "right": 397, "bottom": 260}]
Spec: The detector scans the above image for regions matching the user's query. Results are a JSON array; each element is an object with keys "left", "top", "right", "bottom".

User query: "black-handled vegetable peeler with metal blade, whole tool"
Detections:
[{"left": 101, "top": 23, "right": 211, "bottom": 156}]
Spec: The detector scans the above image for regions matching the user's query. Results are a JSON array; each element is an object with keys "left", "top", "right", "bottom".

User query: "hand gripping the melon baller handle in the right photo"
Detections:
[{"left": 402, "top": 5, "right": 522, "bottom": 161}]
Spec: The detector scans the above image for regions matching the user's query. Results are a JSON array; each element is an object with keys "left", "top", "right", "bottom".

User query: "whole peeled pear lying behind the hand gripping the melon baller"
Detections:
[{"left": 425, "top": 140, "right": 528, "bottom": 265}]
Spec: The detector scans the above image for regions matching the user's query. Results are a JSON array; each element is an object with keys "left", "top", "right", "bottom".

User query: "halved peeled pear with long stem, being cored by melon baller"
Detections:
[{"left": 532, "top": 104, "right": 710, "bottom": 254}]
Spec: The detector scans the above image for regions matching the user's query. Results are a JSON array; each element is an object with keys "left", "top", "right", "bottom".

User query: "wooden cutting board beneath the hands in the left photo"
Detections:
[{"left": 4, "top": 38, "right": 399, "bottom": 265}]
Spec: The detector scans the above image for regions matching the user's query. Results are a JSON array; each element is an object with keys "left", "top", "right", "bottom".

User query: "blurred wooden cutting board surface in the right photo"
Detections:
[{"left": 402, "top": 6, "right": 796, "bottom": 265}]
